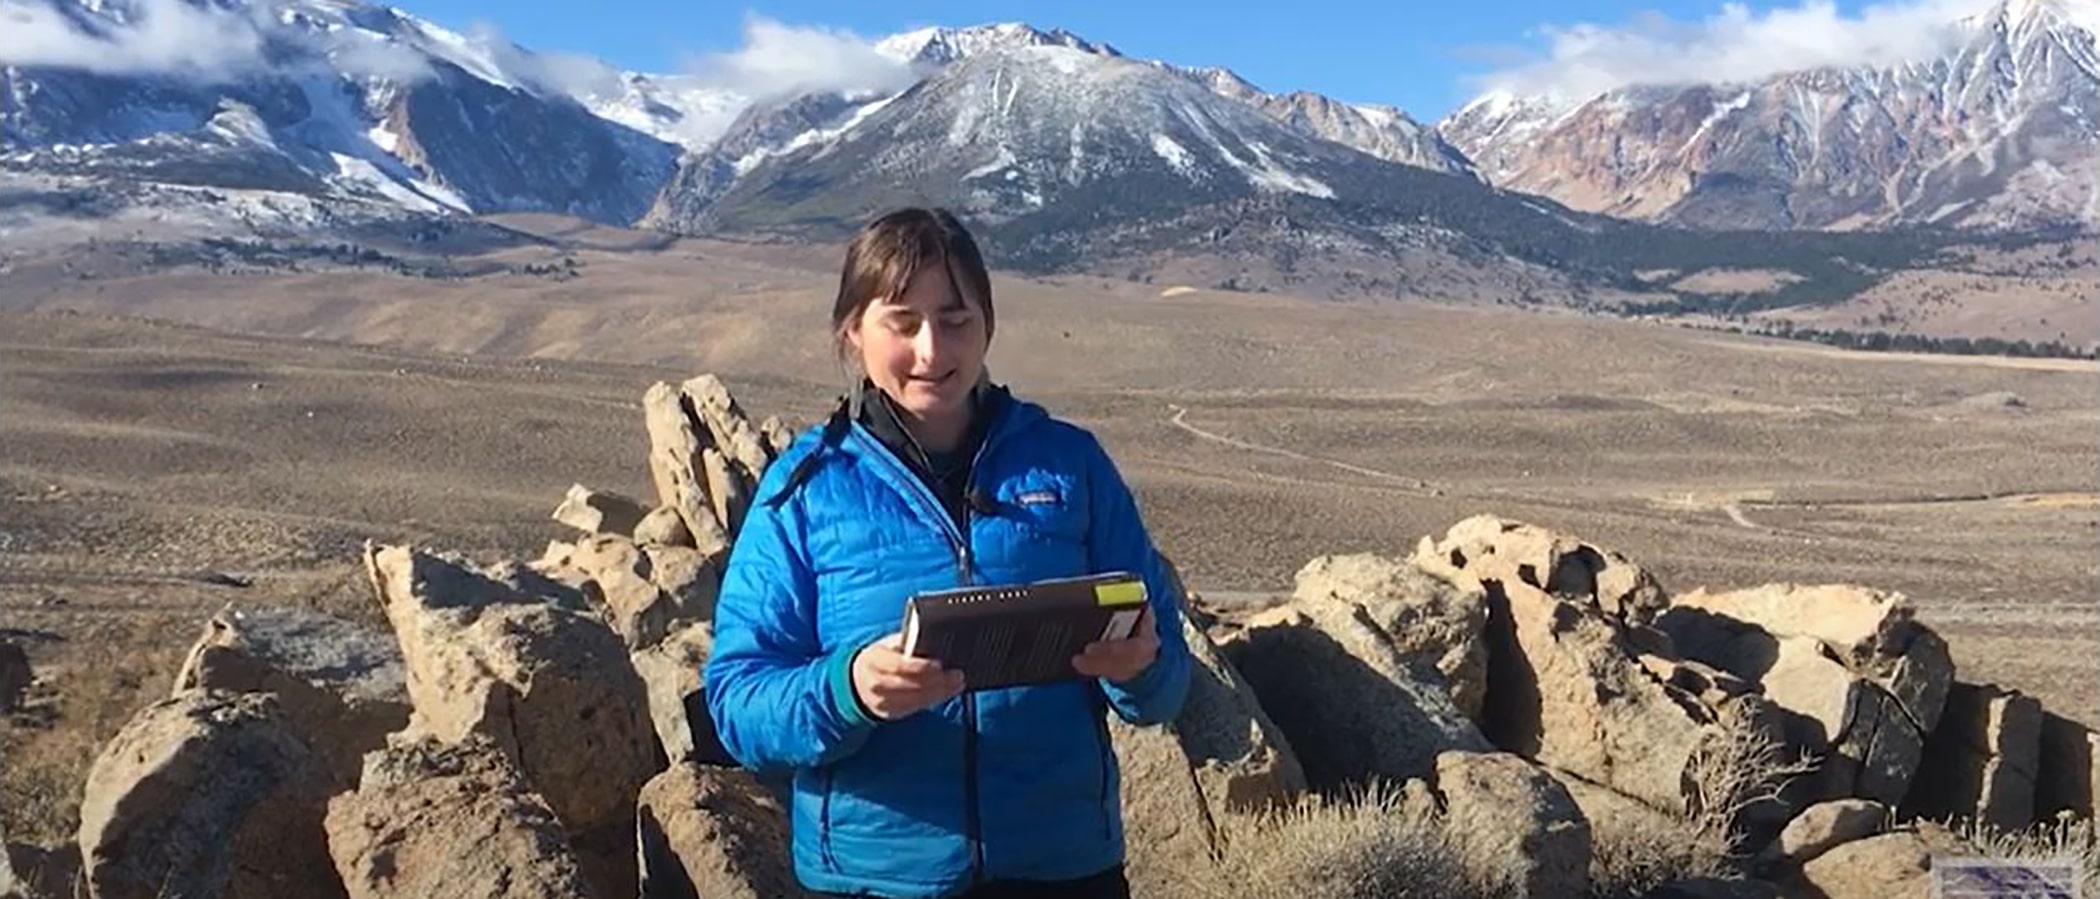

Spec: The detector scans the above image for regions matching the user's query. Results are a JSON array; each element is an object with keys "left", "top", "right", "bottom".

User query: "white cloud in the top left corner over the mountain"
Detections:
[{"left": 0, "top": 0, "right": 265, "bottom": 78}]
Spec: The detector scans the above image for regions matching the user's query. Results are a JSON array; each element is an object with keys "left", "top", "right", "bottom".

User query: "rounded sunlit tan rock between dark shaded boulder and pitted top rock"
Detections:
[{"left": 1294, "top": 552, "right": 1487, "bottom": 720}]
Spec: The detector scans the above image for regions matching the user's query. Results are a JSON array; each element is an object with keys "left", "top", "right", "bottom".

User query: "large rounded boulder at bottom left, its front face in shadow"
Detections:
[{"left": 80, "top": 691, "right": 342, "bottom": 899}]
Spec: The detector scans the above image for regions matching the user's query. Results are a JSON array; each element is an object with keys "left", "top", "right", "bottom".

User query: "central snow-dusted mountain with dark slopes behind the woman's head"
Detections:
[{"left": 647, "top": 42, "right": 1637, "bottom": 277}]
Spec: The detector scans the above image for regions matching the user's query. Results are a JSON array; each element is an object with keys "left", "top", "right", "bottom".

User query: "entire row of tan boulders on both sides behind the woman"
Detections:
[{"left": 0, "top": 376, "right": 2100, "bottom": 899}]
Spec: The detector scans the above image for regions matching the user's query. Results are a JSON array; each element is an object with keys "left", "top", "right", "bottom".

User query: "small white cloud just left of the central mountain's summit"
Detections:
[{"left": 687, "top": 15, "right": 918, "bottom": 99}]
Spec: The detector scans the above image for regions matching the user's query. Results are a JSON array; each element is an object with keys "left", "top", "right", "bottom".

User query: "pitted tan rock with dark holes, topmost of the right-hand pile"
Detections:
[{"left": 1413, "top": 515, "right": 1670, "bottom": 624}]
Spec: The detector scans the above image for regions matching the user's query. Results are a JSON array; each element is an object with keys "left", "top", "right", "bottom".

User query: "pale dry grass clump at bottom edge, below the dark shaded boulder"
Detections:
[{"left": 1212, "top": 786, "right": 1497, "bottom": 899}]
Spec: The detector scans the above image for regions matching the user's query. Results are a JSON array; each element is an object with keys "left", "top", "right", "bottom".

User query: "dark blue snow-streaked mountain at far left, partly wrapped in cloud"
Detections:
[{"left": 0, "top": 0, "right": 688, "bottom": 225}]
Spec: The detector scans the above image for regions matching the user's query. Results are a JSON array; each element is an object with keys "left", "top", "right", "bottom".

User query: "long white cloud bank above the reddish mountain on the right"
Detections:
[{"left": 1468, "top": 0, "right": 1990, "bottom": 99}]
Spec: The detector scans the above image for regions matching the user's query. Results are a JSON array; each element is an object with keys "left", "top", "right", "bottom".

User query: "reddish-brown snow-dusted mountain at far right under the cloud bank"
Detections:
[{"left": 1439, "top": 0, "right": 2100, "bottom": 229}]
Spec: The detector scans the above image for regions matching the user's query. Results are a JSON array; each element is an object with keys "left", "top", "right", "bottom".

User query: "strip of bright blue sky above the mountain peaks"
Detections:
[{"left": 395, "top": 0, "right": 1985, "bottom": 120}]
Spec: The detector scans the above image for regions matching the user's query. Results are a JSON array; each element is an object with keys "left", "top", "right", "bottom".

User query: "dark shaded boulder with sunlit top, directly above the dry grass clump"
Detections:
[{"left": 1222, "top": 603, "right": 1489, "bottom": 792}]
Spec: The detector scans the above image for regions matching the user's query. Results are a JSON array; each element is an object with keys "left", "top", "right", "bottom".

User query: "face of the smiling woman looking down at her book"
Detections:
[{"left": 848, "top": 265, "right": 991, "bottom": 422}]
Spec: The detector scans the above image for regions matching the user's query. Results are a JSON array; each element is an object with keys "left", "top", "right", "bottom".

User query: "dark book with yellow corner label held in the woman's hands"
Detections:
[{"left": 903, "top": 571, "right": 1147, "bottom": 691}]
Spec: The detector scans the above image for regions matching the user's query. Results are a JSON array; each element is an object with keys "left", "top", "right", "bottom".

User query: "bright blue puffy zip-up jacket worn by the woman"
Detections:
[{"left": 706, "top": 390, "right": 1189, "bottom": 897}]
